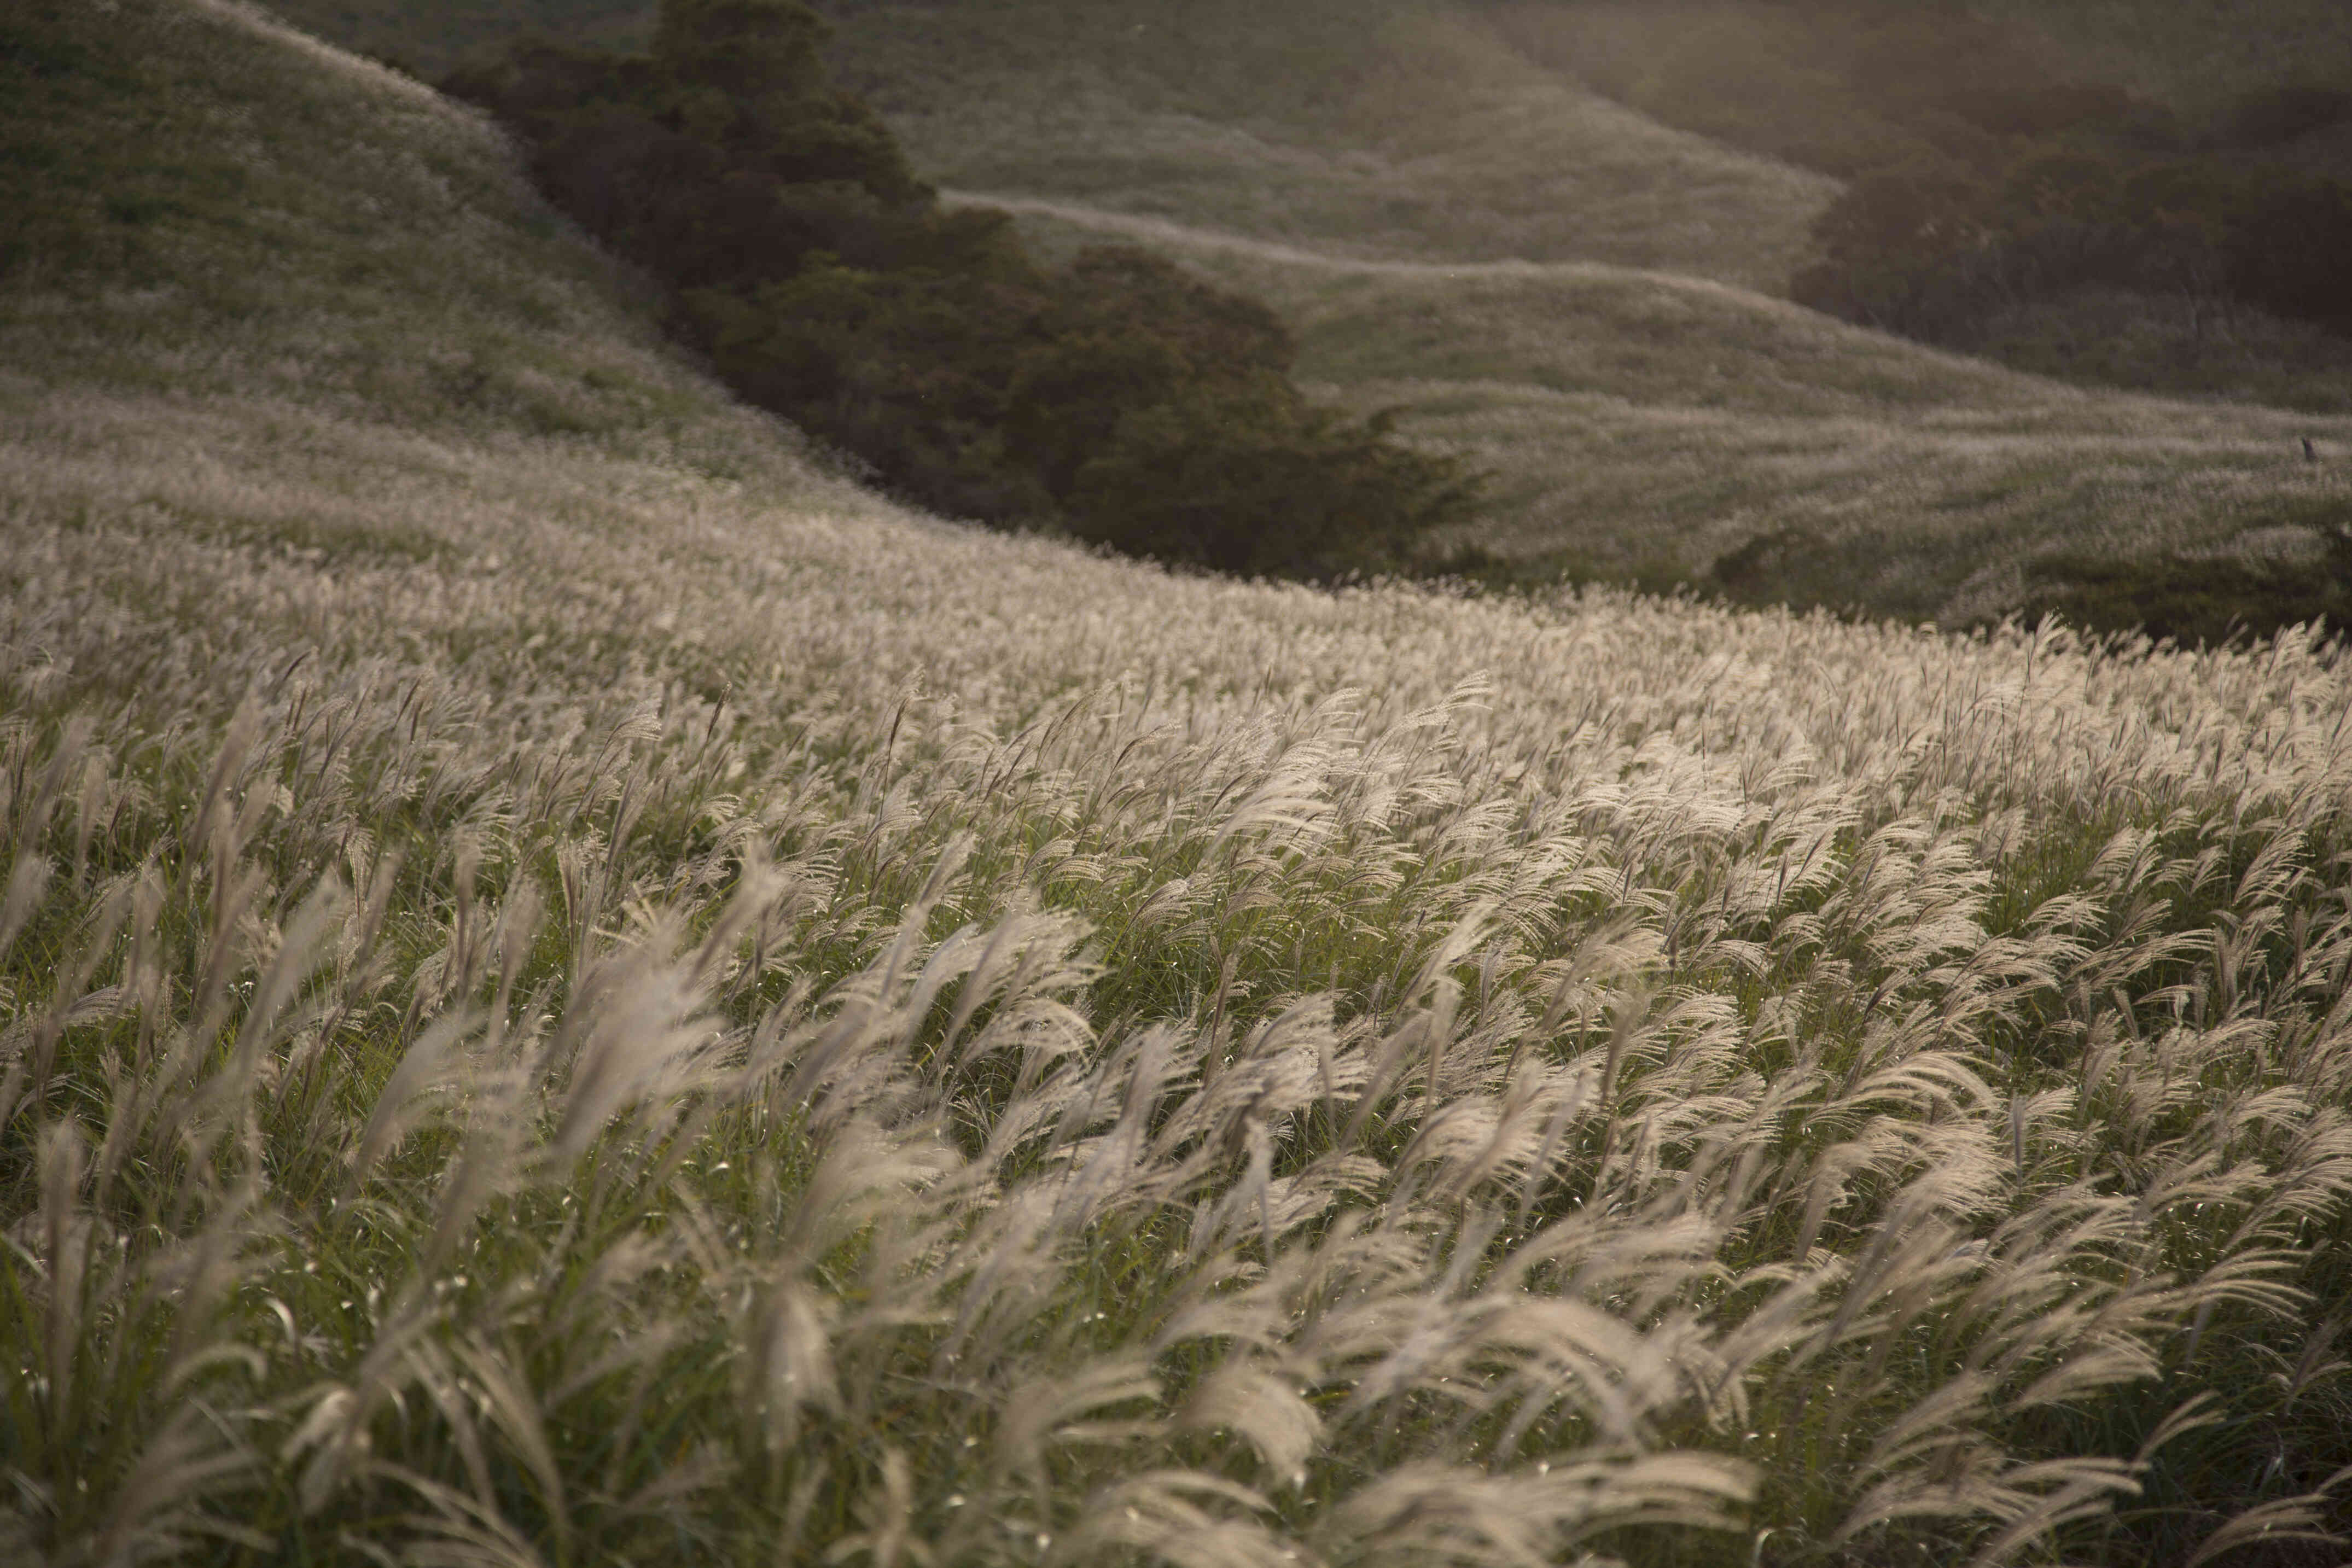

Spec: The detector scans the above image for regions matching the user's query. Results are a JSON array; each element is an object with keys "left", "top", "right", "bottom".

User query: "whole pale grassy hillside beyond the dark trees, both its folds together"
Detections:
[{"left": 253, "top": 0, "right": 2352, "bottom": 623}]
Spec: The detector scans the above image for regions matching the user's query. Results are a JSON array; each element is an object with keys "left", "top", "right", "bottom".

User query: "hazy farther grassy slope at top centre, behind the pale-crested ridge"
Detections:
[{"left": 821, "top": 0, "right": 1837, "bottom": 289}]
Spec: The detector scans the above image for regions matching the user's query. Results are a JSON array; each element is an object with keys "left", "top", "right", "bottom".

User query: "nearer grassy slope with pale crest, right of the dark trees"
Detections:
[{"left": 969, "top": 193, "right": 2352, "bottom": 625}]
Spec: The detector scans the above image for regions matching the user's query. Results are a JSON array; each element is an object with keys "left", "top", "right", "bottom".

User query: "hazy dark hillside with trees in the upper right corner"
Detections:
[{"left": 1484, "top": 0, "right": 2352, "bottom": 414}]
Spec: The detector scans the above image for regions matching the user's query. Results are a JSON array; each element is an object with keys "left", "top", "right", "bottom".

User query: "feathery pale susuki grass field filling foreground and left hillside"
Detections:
[{"left": 14, "top": 0, "right": 2352, "bottom": 1568}]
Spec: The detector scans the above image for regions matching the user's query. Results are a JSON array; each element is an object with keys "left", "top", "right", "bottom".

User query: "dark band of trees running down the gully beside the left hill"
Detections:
[{"left": 445, "top": 0, "right": 1477, "bottom": 578}]
